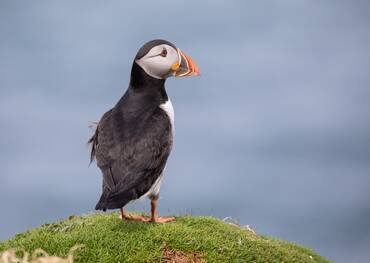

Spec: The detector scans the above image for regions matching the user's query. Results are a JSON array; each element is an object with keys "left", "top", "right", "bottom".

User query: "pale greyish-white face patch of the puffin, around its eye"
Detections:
[{"left": 135, "top": 44, "right": 179, "bottom": 79}]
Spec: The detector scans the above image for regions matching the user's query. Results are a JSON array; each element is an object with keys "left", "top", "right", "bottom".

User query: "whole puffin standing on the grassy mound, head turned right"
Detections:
[{"left": 88, "top": 39, "right": 200, "bottom": 223}]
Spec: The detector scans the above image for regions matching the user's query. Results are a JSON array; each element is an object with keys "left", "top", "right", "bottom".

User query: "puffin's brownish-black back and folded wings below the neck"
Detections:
[{"left": 93, "top": 107, "right": 172, "bottom": 210}]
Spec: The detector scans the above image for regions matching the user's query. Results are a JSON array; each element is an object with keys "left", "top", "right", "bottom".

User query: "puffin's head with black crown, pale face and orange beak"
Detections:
[{"left": 134, "top": 39, "right": 200, "bottom": 79}]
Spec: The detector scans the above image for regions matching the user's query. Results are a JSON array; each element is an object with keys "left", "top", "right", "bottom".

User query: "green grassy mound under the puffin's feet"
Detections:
[{"left": 0, "top": 213, "right": 328, "bottom": 263}]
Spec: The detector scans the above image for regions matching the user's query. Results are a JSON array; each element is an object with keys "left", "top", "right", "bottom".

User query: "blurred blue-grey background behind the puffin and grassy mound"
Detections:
[{"left": 0, "top": 0, "right": 370, "bottom": 262}]
